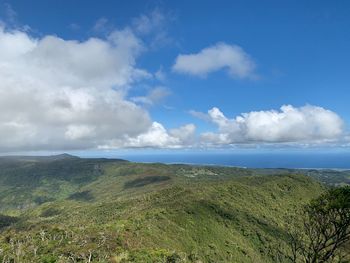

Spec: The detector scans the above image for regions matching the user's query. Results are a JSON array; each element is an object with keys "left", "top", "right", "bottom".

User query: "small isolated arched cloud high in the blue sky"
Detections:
[{"left": 173, "top": 43, "right": 255, "bottom": 78}]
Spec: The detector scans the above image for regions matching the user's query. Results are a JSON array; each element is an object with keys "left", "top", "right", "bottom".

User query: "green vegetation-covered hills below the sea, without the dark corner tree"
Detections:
[{"left": 0, "top": 155, "right": 349, "bottom": 263}]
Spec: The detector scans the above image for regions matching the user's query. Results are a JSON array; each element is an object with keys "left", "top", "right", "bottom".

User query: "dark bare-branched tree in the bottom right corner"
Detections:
[{"left": 289, "top": 186, "right": 350, "bottom": 263}]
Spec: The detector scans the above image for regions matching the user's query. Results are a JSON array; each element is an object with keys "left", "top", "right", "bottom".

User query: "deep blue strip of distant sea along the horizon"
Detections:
[{"left": 117, "top": 153, "right": 350, "bottom": 169}]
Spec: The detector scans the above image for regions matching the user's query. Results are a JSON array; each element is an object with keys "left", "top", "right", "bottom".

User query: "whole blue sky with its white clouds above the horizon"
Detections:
[{"left": 0, "top": 0, "right": 350, "bottom": 153}]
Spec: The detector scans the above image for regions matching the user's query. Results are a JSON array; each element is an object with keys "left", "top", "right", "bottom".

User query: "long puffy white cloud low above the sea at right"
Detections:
[{"left": 201, "top": 105, "right": 343, "bottom": 145}]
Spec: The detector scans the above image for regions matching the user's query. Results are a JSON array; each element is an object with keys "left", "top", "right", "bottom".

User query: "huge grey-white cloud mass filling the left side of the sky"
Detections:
[{"left": 0, "top": 27, "right": 156, "bottom": 151}]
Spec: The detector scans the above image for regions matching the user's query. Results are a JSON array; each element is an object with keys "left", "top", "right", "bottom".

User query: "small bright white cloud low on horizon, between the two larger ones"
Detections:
[{"left": 100, "top": 122, "right": 196, "bottom": 149}]
